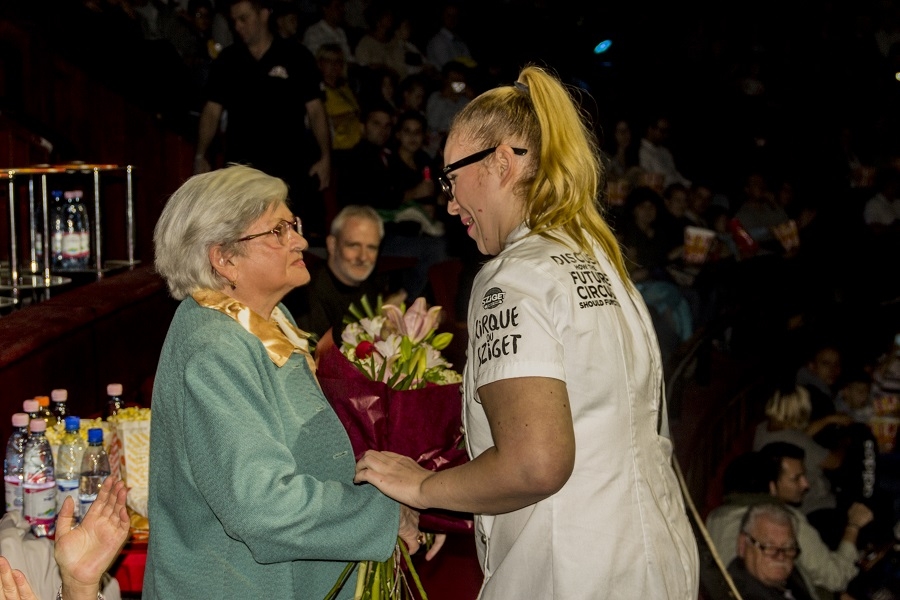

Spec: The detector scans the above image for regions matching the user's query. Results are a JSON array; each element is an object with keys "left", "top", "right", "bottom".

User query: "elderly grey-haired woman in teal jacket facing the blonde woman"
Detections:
[{"left": 143, "top": 165, "right": 419, "bottom": 600}]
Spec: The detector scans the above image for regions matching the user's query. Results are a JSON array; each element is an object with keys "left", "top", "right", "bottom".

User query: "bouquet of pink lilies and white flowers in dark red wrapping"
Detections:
[{"left": 316, "top": 298, "right": 473, "bottom": 598}]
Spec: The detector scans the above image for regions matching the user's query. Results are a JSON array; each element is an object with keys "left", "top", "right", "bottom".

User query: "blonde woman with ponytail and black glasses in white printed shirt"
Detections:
[{"left": 356, "top": 67, "right": 698, "bottom": 600}]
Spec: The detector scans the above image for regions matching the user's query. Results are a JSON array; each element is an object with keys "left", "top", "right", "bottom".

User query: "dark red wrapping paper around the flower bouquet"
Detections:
[{"left": 316, "top": 331, "right": 473, "bottom": 533}]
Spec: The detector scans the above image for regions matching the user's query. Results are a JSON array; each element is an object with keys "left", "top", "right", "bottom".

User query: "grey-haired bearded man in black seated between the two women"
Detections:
[{"left": 282, "top": 204, "right": 406, "bottom": 340}]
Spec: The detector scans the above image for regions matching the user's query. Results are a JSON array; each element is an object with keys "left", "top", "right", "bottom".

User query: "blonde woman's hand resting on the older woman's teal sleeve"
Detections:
[{"left": 353, "top": 450, "right": 434, "bottom": 510}]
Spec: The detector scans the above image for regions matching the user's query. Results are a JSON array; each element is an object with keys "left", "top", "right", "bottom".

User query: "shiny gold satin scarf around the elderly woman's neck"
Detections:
[{"left": 191, "top": 289, "right": 316, "bottom": 375}]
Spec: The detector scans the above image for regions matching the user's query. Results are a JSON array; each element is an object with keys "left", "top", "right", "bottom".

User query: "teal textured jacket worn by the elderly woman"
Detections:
[{"left": 143, "top": 298, "right": 400, "bottom": 600}]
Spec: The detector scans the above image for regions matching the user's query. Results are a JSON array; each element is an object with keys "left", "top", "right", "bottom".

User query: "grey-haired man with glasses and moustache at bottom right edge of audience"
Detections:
[{"left": 728, "top": 501, "right": 816, "bottom": 600}]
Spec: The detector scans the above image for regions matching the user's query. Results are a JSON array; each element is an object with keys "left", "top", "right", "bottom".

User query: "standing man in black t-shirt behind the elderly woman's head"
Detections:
[{"left": 194, "top": 0, "right": 331, "bottom": 243}]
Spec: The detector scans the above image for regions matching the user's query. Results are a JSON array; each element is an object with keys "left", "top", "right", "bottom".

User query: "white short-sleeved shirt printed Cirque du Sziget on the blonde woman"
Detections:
[{"left": 463, "top": 225, "right": 698, "bottom": 600}]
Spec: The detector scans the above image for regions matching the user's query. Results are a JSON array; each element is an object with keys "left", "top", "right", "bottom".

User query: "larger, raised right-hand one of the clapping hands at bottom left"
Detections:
[{"left": 53, "top": 476, "right": 131, "bottom": 600}]
